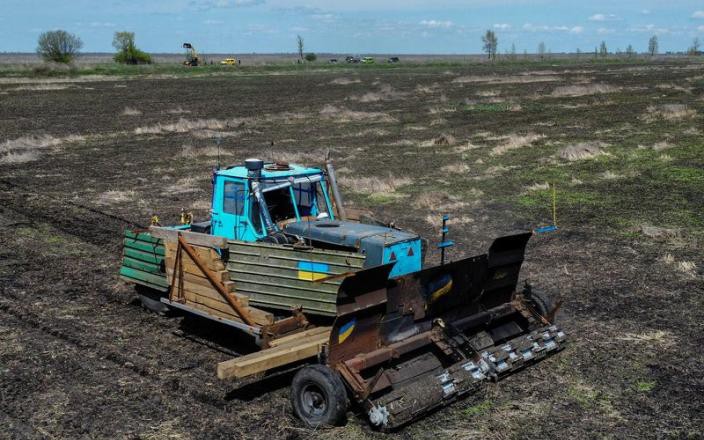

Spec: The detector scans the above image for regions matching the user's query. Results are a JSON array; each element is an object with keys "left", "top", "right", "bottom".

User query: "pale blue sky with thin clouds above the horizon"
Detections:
[{"left": 0, "top": 0, "right": 704, "bottom": 54}]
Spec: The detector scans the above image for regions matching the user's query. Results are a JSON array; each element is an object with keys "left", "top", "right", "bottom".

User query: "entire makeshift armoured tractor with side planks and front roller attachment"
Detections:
[{"left": 120, "top": 159, "right": 566, "bottom": 430}]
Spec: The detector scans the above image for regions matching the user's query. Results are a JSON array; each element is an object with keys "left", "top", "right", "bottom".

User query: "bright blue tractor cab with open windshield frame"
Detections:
[{"left": 211, "top": 159, "right": 335, "bottom": 242}]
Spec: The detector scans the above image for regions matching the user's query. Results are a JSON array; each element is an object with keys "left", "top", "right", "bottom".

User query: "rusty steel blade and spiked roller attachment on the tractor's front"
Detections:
[{"left": 324, "top": 233, "right": 566, "bottom": 431}]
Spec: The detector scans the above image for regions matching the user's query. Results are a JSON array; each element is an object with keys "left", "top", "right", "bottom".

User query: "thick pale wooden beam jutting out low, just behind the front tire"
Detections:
[{"left": 217, "top": 334, "right": 328, "bottom": 380}]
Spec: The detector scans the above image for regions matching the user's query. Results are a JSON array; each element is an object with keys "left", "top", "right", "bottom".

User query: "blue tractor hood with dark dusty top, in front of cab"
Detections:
[{"left": 284, "top": 220, "right": 422, "bottom": 277}]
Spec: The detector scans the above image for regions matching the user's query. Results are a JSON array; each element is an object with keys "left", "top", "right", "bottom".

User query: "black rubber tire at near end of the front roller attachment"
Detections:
[{"left": 291, "top": 365, "right": 349, "bottom": 428}]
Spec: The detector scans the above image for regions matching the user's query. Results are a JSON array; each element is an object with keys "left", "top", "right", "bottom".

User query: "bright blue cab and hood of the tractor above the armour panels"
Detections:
[{"left": 204, "top": 159, "right": 425, "bottom": 277}]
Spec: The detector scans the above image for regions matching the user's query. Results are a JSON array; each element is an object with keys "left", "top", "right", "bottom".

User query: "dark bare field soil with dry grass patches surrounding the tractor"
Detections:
[{"left": 0, "top": 60, "right": 704, "bottom": 439}]
